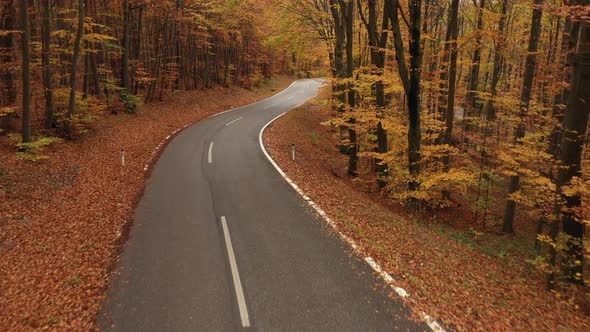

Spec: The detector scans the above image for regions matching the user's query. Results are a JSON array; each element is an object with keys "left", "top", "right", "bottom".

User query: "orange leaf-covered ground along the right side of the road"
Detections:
[{"left": 265, "top": 89, "right": 590, "bottom": 331}]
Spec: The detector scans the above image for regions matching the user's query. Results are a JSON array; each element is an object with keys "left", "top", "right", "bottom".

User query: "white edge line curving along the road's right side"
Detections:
[{"left": 258, "top": 111, "right": 446, "bottom": 332}]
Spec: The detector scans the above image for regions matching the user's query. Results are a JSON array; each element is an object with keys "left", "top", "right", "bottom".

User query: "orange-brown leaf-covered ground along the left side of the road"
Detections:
[{"left": 0, "top": 77, "right": 292, "bottom": 331}]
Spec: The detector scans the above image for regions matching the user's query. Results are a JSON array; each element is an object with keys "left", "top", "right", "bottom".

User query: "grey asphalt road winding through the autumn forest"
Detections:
[{"left": 97, "top": 80, "right": 426, "bottom": 331}]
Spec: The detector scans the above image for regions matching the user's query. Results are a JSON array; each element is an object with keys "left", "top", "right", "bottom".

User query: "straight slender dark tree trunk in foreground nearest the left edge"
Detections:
[{"left": 19, "top": 0, "right": 32, "bottom": 143}]
